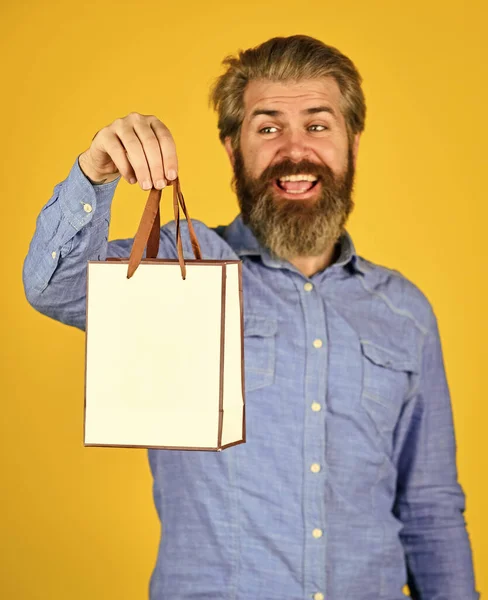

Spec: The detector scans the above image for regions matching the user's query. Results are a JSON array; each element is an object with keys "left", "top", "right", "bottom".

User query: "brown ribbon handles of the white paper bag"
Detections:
[{"left": 127, "top": 178, "right": 202, "bottom": 279}]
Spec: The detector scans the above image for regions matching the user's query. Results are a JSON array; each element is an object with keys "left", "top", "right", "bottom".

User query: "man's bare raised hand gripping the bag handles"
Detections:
[{"left": 79, "top": 112, "right": 178, "bottom": 190}]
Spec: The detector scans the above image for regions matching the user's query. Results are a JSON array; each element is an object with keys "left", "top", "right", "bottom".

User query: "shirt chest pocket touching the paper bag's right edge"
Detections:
[{"left": 244, "top": 315, "right": 278, "bottom": 392}]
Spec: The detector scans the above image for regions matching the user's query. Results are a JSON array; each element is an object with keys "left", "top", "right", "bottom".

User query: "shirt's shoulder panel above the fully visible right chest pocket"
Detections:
[{"left": 358, "top": 256, "right": 435, "bottom": 332}]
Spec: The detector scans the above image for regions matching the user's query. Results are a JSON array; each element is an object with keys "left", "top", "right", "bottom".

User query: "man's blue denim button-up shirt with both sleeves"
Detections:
[{"left": 23, "top": 161, "right": 478, "bottom": 600}]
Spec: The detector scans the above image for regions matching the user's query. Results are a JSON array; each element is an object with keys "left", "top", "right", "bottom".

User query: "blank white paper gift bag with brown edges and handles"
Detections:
[{"left": 84, "top": 180, "right": 245, "bottom": 451}]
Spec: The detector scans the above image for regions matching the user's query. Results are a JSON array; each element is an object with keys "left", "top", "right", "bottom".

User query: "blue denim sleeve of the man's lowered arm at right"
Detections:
[{"left": 394, "top": 313, "right": 479, "bottom": 600}]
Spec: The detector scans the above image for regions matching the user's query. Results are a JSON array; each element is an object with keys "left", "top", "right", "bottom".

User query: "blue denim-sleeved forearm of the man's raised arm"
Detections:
[{"left": 23, "top": 155, "right": 116, "bottom": 329}]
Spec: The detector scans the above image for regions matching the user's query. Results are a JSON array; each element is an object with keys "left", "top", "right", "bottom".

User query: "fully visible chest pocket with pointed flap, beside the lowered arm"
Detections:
[{"left": 361, "top": 340, "right": 418, "bottom": 434}]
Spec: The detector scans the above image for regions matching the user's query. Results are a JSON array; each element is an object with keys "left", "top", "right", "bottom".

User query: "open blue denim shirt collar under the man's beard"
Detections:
[{"left": 219, "top": 214, "right": 366, "bottom": 275}]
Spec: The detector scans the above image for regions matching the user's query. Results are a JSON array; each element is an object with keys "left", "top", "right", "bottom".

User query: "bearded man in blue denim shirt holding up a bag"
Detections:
[{"left": 24, "top": 36, "right": 478, "bottom": 600}]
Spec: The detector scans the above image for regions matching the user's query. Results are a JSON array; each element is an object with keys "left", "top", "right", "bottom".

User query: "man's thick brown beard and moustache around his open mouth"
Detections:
[{"left": 233, "top": 148, "right": 354, "bottom": 260}]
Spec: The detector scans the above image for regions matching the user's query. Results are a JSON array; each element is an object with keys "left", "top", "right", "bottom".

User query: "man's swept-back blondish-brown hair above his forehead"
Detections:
[{"left": 210, "top": 35, "right": 366, "bottom": 149}]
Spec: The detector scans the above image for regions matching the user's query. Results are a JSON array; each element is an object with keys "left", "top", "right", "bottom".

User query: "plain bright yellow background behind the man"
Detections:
[{"left": 0, "top": 0, "right": 488, "bottom": 600}]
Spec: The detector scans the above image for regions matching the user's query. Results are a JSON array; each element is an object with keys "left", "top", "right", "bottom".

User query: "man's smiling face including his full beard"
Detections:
[{"left": 225, "top": 77, "right": 359, "bottom": 258}]
